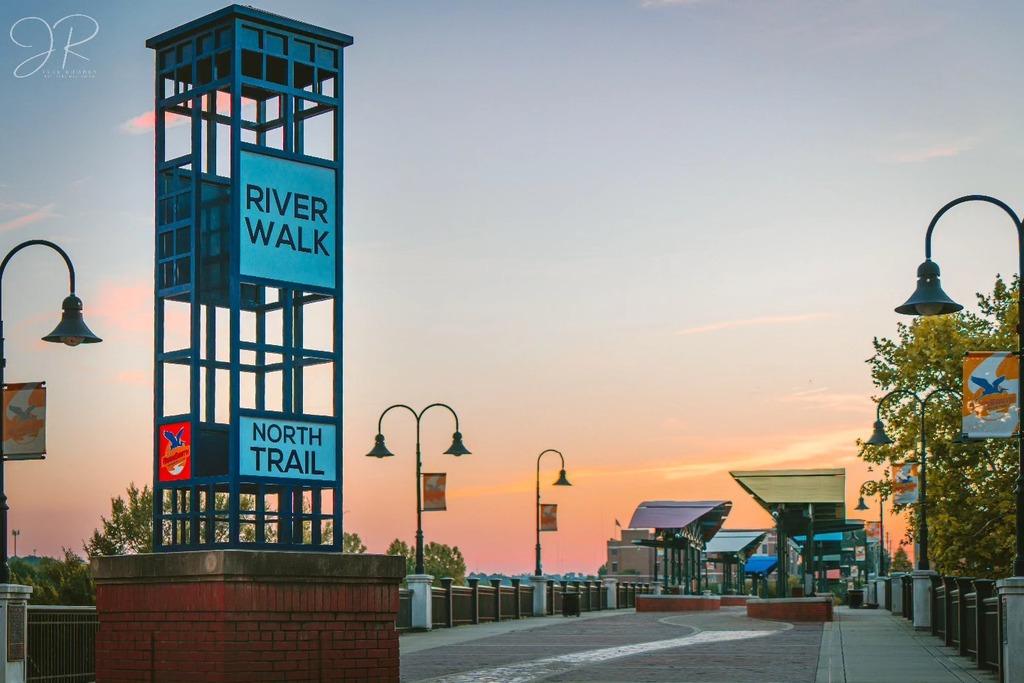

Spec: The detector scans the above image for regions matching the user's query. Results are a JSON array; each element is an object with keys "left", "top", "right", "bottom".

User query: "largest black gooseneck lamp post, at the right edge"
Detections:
[{"left": 896, "top": 195, "right": 1024, "bottom": 577}]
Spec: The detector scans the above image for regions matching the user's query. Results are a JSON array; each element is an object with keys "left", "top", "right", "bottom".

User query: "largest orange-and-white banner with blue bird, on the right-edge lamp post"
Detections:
[{"left": 963, "top": 351, "right": 1020, "bottom": 438}]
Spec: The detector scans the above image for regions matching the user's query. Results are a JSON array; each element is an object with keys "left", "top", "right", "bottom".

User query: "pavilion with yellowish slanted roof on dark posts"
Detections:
[{"left": 730, "top": 468, "right": 863, "bottom": 598}]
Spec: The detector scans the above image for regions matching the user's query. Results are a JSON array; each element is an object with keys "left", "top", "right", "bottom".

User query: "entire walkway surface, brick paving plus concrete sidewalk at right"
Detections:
[{"left": 399, "top": 607, "right": 996, "bottom": 683}]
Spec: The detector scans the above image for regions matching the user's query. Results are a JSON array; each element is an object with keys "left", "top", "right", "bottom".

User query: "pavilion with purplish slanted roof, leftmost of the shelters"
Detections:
[{"left": 630, "top": 501, "right": 732, "bottom": 595}]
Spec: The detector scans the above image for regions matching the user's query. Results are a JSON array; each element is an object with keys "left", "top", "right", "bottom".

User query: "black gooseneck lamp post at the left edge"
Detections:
[{"left": 0, "top": 240, "right": 102, "bottom": 584}]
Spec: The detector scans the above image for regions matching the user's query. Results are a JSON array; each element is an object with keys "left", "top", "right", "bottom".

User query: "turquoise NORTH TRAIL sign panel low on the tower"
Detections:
[{"left": 239, "top": 416, "right": 338, "bottom": 482}]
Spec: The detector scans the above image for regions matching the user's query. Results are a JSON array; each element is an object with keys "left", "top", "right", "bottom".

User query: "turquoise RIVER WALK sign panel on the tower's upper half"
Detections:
[{"left": 239, "top": 151, "right": 338, "bottom": 289}]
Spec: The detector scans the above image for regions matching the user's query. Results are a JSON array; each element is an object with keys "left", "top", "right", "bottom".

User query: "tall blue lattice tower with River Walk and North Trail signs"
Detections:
[{"left": 146, "top": 5, "right": 352, "bottom": 551}]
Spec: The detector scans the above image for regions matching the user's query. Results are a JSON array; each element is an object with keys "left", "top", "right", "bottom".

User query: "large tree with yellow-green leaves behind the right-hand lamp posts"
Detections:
[{"left": 860, "top": 278, "right": 1018, "bottom": 578}]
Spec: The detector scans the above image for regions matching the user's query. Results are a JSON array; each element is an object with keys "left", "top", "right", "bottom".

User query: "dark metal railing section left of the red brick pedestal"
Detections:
[{"left": 26, "top": 605, "right": 99, "bottom": 683}]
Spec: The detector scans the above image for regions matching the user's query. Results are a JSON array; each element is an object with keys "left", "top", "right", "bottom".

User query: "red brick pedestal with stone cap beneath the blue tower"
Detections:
[{"left": 92, "top": 550, "right": 406, "bottom": 683}]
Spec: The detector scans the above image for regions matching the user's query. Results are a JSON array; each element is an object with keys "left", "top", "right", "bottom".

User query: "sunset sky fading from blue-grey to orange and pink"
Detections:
[{"left": 0, "top": 0, "right": 1024, "bottom": 572}]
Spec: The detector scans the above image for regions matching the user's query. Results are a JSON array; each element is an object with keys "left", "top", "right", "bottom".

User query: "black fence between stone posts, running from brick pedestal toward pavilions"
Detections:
[{"left": 396, "top": 579, "right": 654, "bottom": 630}]
